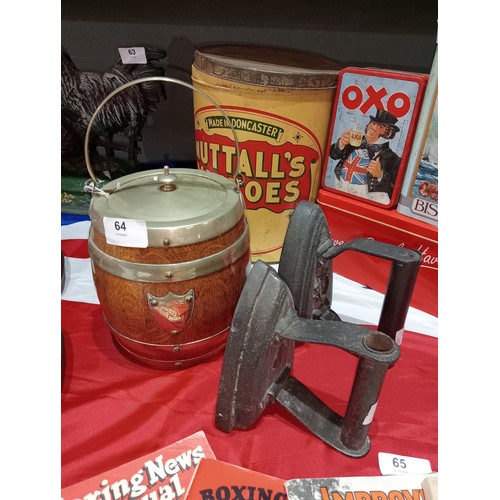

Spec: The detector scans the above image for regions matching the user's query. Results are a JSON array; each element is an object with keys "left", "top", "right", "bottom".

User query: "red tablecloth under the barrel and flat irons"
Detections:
[{"left": 62, "top": 301, "right": 438, "bottom": 487}]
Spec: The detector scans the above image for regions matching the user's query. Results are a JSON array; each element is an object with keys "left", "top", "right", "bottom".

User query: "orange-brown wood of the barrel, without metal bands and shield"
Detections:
[{"left": 92, "top": 219, "right": 249, "bottom": 361}]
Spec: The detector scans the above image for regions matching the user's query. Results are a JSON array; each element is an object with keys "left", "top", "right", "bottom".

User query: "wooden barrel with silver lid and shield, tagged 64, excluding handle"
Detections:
[{"left": 89, "top": 167, "right": 250, "bottom": 368}]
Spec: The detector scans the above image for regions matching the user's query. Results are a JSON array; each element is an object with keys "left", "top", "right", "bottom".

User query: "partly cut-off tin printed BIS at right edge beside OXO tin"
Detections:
[{"left": 397, "top": 47, "right": 438, "bottom": 226}]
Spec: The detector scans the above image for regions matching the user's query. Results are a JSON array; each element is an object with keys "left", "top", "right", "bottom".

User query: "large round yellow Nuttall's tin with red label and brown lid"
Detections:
[{"left": 192, "top": 44, "right": 341, "bottom": 262}]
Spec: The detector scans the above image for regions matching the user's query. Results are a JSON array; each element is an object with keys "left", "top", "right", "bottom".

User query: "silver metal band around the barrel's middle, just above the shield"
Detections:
[{"left": 88, "top": 222, "right": 249, "bottom": 283}]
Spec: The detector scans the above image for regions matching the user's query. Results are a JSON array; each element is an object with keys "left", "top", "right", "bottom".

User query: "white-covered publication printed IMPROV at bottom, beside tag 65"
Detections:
[{"left": 285, "top": 474, "right": 437, "bottom": 500}]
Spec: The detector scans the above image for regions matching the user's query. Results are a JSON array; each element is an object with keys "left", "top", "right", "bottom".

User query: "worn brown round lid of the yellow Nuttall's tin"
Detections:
[{"left": 193, "top": 44, "right": 343, "bottom": 88}]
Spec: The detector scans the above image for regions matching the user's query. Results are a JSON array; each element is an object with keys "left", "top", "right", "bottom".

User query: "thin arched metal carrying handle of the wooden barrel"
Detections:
[{"left": 84, "top": 76, "right": 243, "bottom": 194}]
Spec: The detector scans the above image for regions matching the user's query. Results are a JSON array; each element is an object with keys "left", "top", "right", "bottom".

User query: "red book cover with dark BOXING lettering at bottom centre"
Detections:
[{"left": 186, "top": 458, "right": 286, "bottom": 500}]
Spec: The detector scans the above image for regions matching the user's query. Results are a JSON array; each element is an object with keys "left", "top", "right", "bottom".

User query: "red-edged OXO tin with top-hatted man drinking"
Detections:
[{"left": 323, "top": 67, "right": 428, "bottom": 209}]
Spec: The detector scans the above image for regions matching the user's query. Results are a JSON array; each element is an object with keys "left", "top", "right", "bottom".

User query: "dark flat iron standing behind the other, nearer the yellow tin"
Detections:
[{"left": 278, "top": 201, "right": 422, "bottom": 344}]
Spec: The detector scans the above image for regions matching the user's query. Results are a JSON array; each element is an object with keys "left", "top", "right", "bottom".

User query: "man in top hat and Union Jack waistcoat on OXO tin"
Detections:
[{"left": 330, "top": 109, "right": 401, "bottom": 205}]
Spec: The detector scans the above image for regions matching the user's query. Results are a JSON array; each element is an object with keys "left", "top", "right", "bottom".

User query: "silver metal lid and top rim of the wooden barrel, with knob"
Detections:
[{"left": 89, "top": 167, "right": 244, "bottom": 247}]
